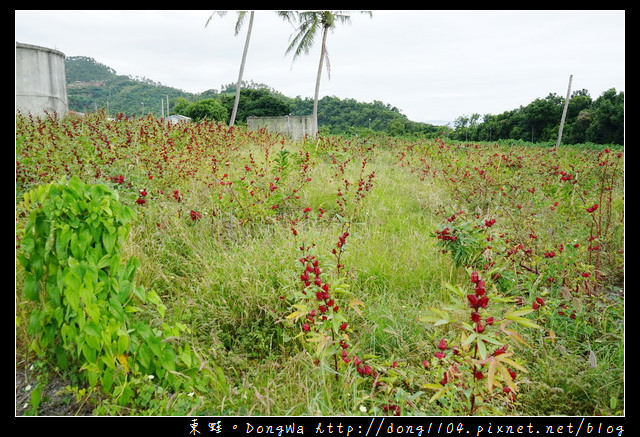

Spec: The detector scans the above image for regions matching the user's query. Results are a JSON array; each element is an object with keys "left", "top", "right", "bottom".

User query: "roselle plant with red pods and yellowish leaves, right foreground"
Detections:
[{"left": 421, "top": 270, "right": 544, "bottom": 414}]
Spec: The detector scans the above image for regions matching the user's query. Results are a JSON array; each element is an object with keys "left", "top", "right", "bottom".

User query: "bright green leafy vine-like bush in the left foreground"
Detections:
[{"left": 18, "top": 177, "right": 222, "bottom": 405}]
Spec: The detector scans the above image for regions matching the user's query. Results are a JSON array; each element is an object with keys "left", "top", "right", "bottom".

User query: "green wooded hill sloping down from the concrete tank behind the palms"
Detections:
[{"left": 66, "top": 56, "right": 442, "bottom": 134}]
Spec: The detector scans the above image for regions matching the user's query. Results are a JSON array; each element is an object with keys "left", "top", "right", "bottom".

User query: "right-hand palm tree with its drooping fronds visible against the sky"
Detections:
[{"left": 286, "top": 11, "right": 371, "bottom": 135}]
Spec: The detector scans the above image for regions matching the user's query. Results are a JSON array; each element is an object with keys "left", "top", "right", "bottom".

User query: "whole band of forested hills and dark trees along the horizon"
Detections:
[{"left": 66, "top": 56, "right": 624, "bottom": 145}]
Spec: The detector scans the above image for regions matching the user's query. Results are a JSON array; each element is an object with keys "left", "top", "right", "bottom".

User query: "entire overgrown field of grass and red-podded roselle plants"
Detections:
[{"left": 15, "top": 113, "right": 624, "bottom": 416}]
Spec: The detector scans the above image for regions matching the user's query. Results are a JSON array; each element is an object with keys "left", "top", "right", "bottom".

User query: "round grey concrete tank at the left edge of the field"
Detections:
[{"left": 16, "top": 43, "right": 69, "bottom": 117}]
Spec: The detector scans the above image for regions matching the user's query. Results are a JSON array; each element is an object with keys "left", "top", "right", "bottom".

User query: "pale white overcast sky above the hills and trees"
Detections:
[{"left": 15, "top": 10, "right": 625, "bottom": 122}]
